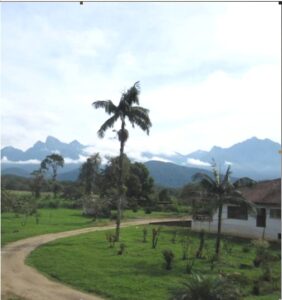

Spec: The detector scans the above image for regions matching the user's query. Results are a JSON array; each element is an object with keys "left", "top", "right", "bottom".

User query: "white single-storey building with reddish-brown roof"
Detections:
[{"left": 192, "top": 179, "right": 281, "bottom": 240}]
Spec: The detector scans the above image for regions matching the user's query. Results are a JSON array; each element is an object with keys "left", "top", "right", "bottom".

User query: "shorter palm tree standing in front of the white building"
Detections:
[{"left": 193, "top": 162, "right": 255, "bottom": 257}]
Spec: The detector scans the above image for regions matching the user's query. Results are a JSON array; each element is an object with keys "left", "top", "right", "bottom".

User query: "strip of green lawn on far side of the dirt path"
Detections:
[{"left": 1, "top": 208, "right": 186, "bottom": 246}]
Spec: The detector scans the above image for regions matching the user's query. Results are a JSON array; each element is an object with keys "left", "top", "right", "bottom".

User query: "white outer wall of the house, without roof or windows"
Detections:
[{"left": 192, "top": 205, "right": 281, "bottom": 240}]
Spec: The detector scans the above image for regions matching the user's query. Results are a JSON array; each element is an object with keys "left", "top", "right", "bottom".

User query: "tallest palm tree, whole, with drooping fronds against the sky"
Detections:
[{"left": 92, "top": 81, "right": 152, "bottom": 241}]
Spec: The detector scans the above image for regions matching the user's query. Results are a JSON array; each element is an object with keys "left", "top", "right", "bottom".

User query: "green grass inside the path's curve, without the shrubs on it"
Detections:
[{"left": 27, "top": 226, "right": 280, "bottom": 300}]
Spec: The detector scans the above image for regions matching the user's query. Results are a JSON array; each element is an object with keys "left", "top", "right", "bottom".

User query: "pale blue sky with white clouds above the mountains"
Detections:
[{"left": 1, "top": 2, "right": 281, "bottom": 157}]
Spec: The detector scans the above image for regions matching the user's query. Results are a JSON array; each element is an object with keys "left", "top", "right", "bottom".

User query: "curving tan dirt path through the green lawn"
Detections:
[{"left": 1, "top": 219, "right": 185, "bottom": 300}]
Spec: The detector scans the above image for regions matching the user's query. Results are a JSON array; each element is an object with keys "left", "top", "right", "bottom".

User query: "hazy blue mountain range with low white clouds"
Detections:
[{"left": 1, "top": 136, "right": 281, "bottom": 187}]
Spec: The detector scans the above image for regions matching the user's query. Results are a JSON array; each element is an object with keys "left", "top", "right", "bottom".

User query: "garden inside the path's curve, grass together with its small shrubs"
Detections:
[{"left": 28, "top": 226, "right": 280, "bottom": 300}]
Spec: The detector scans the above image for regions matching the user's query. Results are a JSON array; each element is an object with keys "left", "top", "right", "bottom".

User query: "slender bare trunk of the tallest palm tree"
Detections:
[{"left": 116, "top": 121, "right": 125, "bottom": 242}]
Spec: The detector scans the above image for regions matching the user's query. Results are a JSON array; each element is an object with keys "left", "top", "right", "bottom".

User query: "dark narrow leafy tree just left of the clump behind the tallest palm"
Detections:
[{"left": 79, "top": 153, "right": 101, "bottom": 195}]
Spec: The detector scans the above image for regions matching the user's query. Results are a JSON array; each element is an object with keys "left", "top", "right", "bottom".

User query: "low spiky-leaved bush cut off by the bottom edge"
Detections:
[{"left": 173, "top": 274, "right": 241, "bottom": 300}]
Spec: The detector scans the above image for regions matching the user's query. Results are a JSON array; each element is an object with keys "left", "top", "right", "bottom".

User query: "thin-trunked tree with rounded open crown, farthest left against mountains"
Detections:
[{"left": 40, "top": 153, "right": 64, "bottom": 198}]
